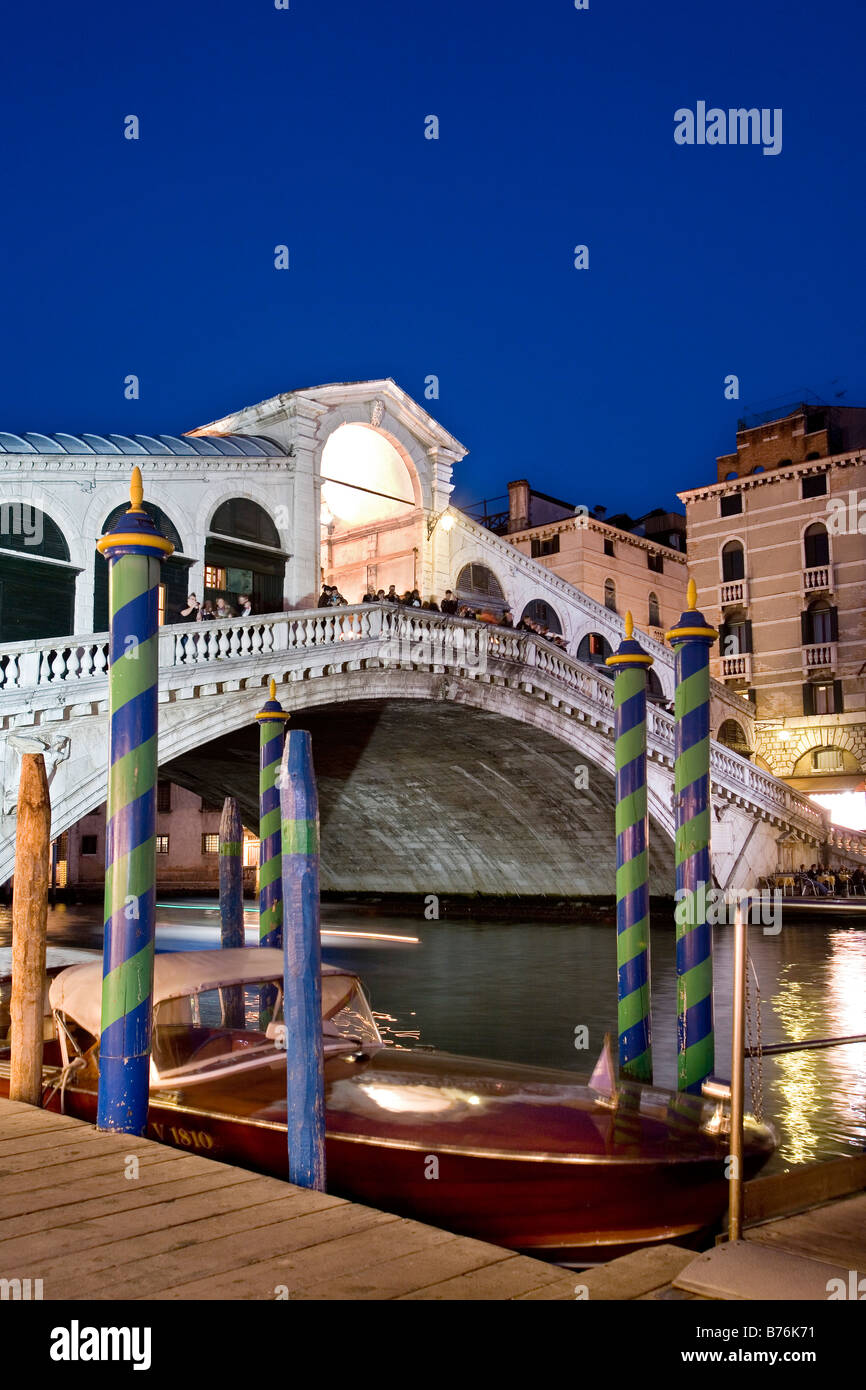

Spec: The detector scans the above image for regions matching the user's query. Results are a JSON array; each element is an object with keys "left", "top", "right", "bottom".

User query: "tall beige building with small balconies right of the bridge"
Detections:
[{"left": 680, "top": 404, "right": 866, "bottom": 811}]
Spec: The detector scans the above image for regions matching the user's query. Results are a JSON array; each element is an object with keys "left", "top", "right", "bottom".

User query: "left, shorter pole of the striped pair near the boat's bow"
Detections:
[{"left": 607, "top": 613, "right": 652, "bottom": 1081}]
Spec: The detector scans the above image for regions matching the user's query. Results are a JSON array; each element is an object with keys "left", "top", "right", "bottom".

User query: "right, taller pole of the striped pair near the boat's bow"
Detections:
[{"left": 667, "top": 580, "right": 719, "bottom": 1095}]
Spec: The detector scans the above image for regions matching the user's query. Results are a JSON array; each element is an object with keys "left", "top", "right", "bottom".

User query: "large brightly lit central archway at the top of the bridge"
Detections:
[{"left": 320, "top": 423, "right": 422, "bottom": 603}]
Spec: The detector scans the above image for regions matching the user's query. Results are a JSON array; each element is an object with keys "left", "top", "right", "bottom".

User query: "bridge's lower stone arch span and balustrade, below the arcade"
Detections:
[{"left": 0, "top": 603, "right": 839, "bottom": 895}]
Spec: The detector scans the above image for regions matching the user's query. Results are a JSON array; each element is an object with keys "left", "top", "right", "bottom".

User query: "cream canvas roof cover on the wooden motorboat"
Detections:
[{"left": 49, "top": 947, "right": 353, "bottom": 1037}]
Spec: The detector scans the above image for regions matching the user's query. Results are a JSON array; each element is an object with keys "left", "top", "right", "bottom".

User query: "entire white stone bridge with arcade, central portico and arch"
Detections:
[{"left": 0, "top": 379, "right": 862, "bottom": 895}]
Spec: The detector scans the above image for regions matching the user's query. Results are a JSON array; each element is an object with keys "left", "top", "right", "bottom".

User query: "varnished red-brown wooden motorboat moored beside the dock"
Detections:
[{"left": 0, "top": 947, "right": 776, "bottom": 1264}]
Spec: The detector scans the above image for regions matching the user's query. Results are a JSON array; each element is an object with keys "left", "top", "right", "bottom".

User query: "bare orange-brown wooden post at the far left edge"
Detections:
[{"left": 8, "top": 753, "right": 51, "bottom": 1105}]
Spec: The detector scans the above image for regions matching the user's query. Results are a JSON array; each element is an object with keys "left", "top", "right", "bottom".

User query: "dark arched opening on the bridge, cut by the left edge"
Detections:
[{"left": 0, "top": 500, "right": 78, "bottom": 642}]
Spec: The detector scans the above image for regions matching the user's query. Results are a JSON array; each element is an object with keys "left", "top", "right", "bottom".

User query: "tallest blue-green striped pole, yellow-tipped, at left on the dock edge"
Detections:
[{"left": 96, "top": 467, "right": 174, "bottom": 1134}]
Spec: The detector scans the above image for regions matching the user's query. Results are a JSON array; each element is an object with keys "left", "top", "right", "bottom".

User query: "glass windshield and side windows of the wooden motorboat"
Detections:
[{"left": 152, "top": 974, "right": 381, "bottom": 1084}]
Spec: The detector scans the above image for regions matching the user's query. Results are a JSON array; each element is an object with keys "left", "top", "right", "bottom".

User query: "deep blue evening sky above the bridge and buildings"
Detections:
[{"left": 0, "top": 0, "right": 866, "bottom": 513}]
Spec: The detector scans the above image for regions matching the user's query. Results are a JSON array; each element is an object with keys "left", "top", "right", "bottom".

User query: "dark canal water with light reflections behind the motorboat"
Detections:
[{"left": 0, "top": 899, "right": 866, "bottom": 1172}]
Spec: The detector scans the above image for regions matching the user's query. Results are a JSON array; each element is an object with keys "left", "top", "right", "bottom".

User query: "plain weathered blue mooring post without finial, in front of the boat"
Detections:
[{"left": 279, "top": 728, "right": 325, "bottom": 1193}]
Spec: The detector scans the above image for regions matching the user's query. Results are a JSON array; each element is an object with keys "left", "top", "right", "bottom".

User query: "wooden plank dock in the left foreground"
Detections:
[{"left": 0, "top": 1101, "right": 580, "bottom": 1301}]
